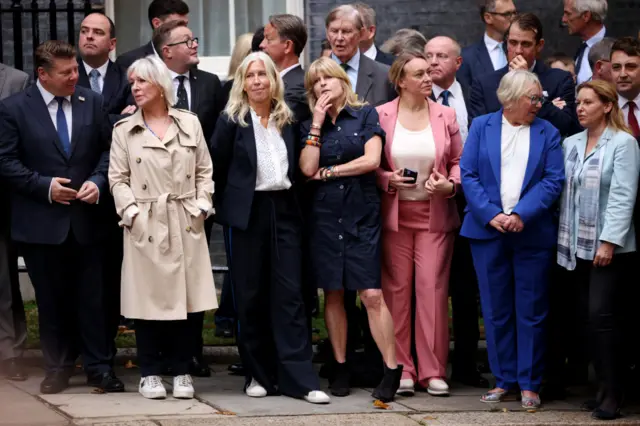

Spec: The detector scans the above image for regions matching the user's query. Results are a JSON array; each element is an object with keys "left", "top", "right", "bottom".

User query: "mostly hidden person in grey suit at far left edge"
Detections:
[{"left": 0, "top": 64, "right": 29, "bottom": 381}]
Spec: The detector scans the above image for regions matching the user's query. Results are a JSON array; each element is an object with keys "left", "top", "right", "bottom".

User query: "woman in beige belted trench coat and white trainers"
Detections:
[{"left": 109, "top": 57, "right": 217, "bottom": 399}]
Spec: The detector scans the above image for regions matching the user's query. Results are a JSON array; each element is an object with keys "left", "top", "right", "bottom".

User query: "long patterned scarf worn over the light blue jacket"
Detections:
[{"left": 558, "top": 129, "right": 610, "bottom": 271}]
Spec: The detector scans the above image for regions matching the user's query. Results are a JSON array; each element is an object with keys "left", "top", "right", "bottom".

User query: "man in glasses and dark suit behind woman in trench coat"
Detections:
[{"left": 153, "top": 20, "right": 224, "bottom": 377}]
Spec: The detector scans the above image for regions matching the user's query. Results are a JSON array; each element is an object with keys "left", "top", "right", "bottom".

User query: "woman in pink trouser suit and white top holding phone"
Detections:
[{"left": 377, "top": 52, "right": 462, "bottom": 395}]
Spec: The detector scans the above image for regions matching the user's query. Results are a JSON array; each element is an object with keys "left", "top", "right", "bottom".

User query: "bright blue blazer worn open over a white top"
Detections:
[{"left": 460, "top": 110, "right": 564, "bottom": 247}]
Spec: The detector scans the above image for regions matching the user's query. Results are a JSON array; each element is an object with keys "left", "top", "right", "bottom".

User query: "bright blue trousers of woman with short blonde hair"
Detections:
[{"left": 470, "top": 234, "right": 555, "bottom": 392}]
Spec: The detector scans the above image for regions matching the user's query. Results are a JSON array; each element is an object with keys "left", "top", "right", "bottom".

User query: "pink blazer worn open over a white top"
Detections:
[{"left": 376, "top": 98, "right": 462, "bottom": 232}]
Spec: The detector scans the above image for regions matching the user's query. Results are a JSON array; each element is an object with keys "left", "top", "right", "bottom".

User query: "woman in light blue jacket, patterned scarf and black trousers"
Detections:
[{"left": 558, "top": 80, "right": 640, "bottom": 420}]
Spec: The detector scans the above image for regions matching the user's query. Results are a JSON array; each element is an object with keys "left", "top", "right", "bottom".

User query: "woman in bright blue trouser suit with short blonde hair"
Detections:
[{"left": 460, "top": 70, "right": 564, "bottom": 408}]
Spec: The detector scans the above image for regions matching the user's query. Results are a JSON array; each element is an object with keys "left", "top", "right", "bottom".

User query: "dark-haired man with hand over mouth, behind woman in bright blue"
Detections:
[{"left": 469, "top": 13, "right": 581, "bottom": 136}]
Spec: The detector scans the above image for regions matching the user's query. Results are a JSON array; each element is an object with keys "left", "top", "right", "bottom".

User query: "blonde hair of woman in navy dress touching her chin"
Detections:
[{"left": 304, "top": 57, "right": 367, "bottom": 112}]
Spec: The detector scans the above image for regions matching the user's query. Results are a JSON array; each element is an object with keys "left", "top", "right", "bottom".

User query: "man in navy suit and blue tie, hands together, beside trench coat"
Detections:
[{"left": 0, "top": 40, "right": 124, "bottom": 394}]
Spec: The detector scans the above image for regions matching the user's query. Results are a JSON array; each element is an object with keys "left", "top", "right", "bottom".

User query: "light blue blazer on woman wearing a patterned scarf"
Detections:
[{"left": 563, "top": 128, "right": 640, "bottom": 253}]
